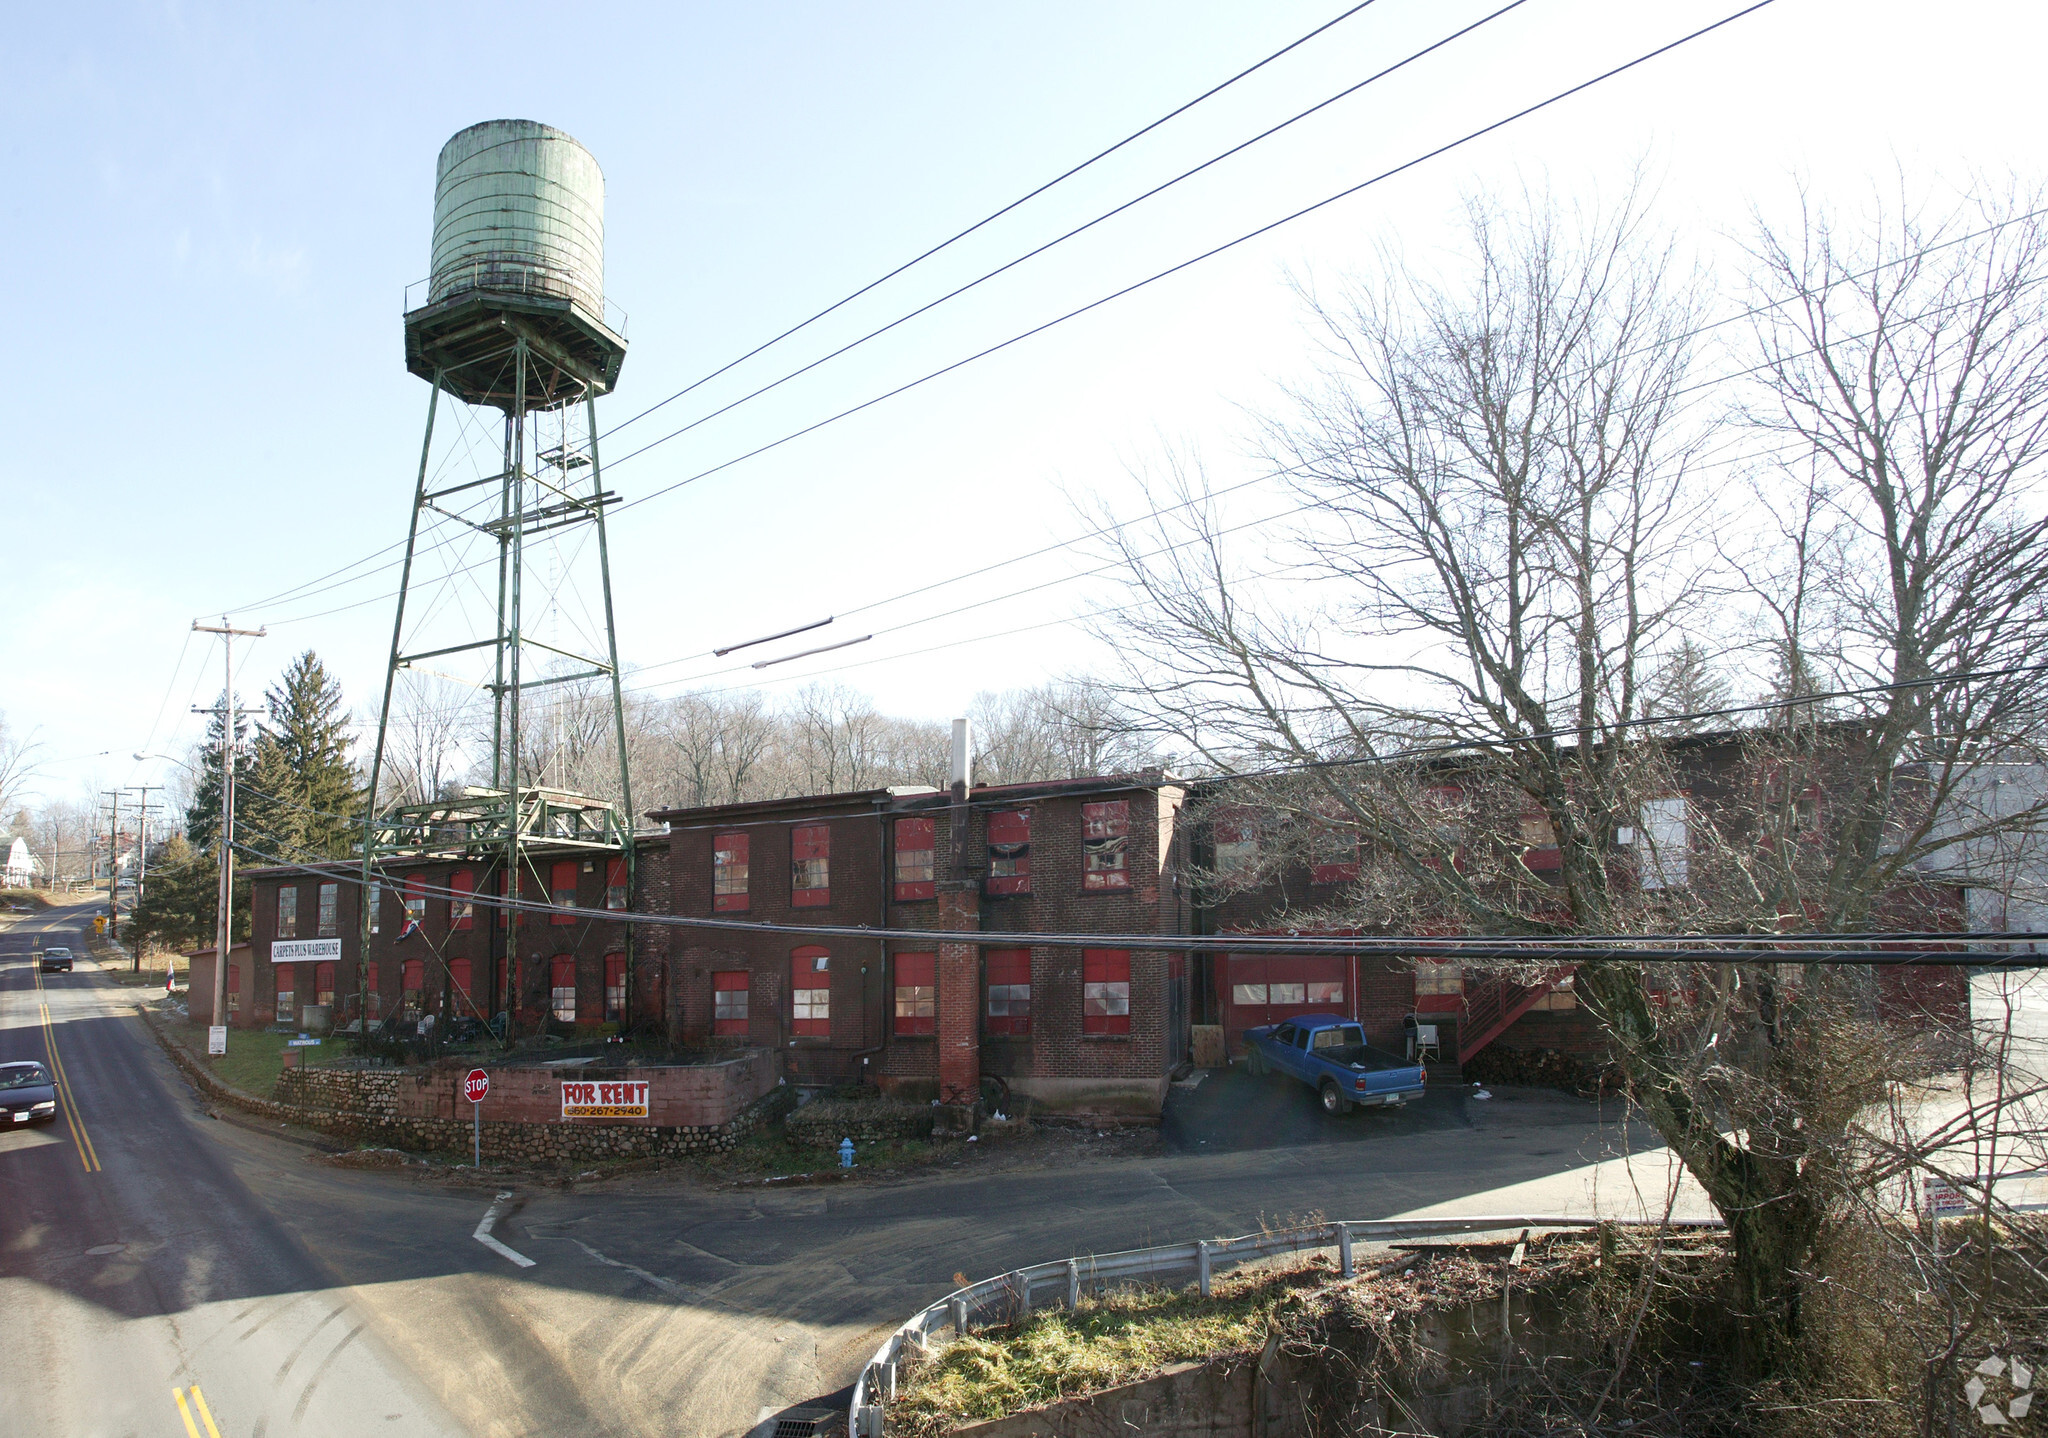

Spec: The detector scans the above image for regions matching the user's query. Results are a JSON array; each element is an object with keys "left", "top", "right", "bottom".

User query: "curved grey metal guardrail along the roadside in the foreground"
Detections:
[{"left": 846, "top": 1215, "right": 1722, "bottom": 1438}]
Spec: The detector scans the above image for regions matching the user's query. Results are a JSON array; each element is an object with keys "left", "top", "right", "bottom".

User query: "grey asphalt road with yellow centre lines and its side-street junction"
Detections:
[{"left": 0, "top": 910, "right": 1640, "bottom": 1438}]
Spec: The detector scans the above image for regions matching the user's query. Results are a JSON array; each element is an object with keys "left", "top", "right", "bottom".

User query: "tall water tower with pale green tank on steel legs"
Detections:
[{"left": 358, "top": 119, "right": 633, "bottom": 1036}]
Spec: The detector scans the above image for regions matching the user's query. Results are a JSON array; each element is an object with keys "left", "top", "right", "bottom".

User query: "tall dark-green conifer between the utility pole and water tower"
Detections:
[{"left": 252, "top": 649, "right": 362, "bottom": 858}]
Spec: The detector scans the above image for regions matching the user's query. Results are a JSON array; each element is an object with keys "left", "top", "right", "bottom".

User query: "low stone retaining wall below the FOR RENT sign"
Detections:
[{"left": 152, "top": 1024, "right": 797, "bottom": 1164}]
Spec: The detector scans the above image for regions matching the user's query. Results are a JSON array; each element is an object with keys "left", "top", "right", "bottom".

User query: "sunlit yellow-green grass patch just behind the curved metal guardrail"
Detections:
[{"left": 889, "top": 1264, "right": 1321, "bottom": 1438}]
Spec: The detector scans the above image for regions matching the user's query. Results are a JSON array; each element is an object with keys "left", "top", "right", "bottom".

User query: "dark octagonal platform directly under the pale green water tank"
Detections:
[{"left": 406, "top": 289, "right": 627, "bottom": 412}]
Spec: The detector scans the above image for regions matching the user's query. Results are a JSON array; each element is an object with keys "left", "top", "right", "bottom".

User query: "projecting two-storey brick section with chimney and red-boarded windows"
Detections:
[{"left": 651, "top": 776, "right": 1192, "bottom": 1110}]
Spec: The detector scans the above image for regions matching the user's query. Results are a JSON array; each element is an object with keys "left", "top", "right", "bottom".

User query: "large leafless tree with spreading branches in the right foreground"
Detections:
[{"left": 1110, "top": 186, "right": 2048, "bottom": 1368}]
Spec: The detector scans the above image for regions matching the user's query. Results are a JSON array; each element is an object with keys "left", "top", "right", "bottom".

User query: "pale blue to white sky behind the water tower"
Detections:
[{"left": 0, "top": 0, "right": 2048, "bottom": 815}]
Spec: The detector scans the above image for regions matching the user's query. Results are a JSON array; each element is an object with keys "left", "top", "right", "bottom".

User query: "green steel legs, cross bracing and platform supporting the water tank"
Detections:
[{"left": 356, "top": 307, "right": 635, "bottom": 1032}]
